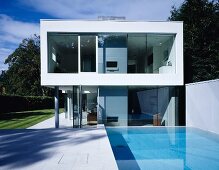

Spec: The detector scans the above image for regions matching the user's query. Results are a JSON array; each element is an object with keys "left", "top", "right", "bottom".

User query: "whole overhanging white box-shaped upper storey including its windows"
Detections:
[{"left": 40, "top": 20, "right": 184, "bottom": 86}]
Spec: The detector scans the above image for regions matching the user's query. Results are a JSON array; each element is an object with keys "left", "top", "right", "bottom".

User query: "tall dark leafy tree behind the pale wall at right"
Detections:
[{"left": 169, "top": 0, "right": 219, "bottom": 83}]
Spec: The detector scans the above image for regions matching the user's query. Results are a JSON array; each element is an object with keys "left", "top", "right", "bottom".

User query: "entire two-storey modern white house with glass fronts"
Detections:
[{"left": 40, "top": 20, "right": 184, "bottom": 127}]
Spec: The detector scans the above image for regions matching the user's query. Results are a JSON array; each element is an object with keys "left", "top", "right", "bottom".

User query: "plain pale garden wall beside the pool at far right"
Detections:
[{"left": 186, "top": 79, "right": 219, "bottom": 134}]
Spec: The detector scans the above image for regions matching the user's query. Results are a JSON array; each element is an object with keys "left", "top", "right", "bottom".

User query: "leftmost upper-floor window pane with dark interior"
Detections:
[{"left": 48, "top": 33, "right": 78, "bottom": 73}]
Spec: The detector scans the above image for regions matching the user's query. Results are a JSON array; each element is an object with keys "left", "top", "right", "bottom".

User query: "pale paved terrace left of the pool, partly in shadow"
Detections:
[{"left": 0, "top": 112, "right": 118, "bottom": 170}]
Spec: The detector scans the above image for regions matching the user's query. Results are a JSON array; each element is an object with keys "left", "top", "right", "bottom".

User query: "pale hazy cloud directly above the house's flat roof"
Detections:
[{"left": 20, "top": 0, "right": 183, "bottom": 20}]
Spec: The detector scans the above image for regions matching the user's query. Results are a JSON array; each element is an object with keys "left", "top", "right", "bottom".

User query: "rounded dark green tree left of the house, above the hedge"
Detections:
[{"left": 1, "top": 35, "right": 50, "bottom": 96}]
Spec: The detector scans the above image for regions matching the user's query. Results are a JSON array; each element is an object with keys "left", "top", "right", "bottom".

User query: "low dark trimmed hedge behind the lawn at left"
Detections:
[{"left": 0, "top": 95, "right": 63, "bottom": 113}]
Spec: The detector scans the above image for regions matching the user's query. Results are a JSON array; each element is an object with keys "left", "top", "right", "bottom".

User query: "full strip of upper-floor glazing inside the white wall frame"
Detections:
[{"left": 48, "top": 33, "right": 176, "bottom": 74}]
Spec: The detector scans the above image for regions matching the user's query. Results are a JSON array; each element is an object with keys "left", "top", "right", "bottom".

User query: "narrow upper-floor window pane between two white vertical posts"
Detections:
[{"left": 80, "top": 35, "right": 96, "bottom": 72}]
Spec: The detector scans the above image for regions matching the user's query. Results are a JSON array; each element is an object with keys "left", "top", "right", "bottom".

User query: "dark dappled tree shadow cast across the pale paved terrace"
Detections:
[{"left": 0, "top": 128, "right": 105, "bottom": 169}]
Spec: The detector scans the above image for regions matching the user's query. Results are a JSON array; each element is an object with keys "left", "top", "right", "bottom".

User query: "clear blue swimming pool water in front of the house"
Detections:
[{"left": 106, "top": 127, "right": 219, "bottom": 170}]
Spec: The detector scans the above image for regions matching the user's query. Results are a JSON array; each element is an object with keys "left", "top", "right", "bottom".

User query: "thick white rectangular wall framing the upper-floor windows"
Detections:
[{"left": 40, "top": 20, "right": 183, "bottom": 86}]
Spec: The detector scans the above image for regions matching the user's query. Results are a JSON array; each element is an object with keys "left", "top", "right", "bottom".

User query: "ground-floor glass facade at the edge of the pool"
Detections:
[{"left": 98, "top": 86, "right": 183, "bottom": 126}]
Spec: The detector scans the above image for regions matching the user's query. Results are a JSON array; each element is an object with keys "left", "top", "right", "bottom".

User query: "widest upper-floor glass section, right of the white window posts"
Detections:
[{"left": 98, "top": 33, "right": 176, "bottom": 74}]
